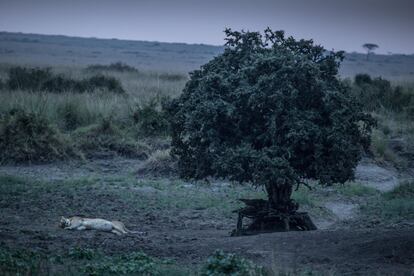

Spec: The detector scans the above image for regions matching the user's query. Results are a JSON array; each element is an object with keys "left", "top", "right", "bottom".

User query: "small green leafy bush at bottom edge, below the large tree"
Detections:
[{"left": 201, "top": 250, "right": 266, "bottom": 276}]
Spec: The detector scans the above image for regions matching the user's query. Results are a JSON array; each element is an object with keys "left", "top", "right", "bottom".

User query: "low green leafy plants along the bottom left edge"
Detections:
[{"left": 0, "top": 247, "right": 190, "bottom": 276}]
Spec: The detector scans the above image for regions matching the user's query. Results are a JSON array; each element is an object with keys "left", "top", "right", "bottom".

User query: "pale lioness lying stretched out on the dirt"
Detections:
[{"left": 60, "top": 217, "right": 145, "bottom": 235}]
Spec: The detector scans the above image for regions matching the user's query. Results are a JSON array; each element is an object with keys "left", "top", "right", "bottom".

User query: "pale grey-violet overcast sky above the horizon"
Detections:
[{"left": 0, "top": 0, "right": 414, "bottom": 54}]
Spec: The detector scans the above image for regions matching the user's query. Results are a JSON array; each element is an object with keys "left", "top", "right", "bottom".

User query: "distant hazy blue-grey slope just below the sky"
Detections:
[{"left": 0, "top": 32, "right": 414, "bottom": 82}]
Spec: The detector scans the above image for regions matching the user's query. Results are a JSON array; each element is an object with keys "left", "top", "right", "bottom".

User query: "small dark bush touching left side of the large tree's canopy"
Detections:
[{"left": 132, "top": 98, "right": 170, "bottom": 136}]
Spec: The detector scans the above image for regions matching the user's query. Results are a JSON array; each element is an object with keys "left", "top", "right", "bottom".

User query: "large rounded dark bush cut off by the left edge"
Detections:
[{"left": 0, "top": 109, "right": 79, "bottom": 163}]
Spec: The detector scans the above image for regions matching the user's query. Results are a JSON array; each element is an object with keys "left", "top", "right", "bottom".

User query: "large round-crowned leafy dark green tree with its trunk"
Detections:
[{"left": 169, "top": 29, "right": 373, "bottom": 234}]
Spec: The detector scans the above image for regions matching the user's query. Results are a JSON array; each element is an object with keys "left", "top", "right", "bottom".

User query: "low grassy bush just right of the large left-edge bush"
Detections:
[{"left": 72, "top": 119, "right": 149, "bottom": 158}]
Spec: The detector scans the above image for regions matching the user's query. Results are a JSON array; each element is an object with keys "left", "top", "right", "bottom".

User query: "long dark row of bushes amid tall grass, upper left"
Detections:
[{"left": 6, "top": 66, "right": 125, "bottom": 93}]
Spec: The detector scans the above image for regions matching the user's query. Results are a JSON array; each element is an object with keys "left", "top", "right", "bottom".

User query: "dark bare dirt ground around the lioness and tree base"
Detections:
[{"left": 0, "top": 159, "right": 414, "bottom": 275}]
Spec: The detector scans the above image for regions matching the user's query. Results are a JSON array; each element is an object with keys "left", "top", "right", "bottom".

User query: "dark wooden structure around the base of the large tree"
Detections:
[{"left": 231, "top": 199, "right": 317, "bottom": 236}]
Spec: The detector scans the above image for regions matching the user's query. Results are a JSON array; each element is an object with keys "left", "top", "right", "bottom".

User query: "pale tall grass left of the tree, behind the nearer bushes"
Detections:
[{"left": 0, "top": 67, "right": 186, "bottom": 129}]
